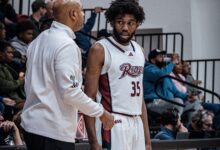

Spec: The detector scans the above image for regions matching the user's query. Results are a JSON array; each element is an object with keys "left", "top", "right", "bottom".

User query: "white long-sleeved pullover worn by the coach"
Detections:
[{"left": 21, "top": 21, "right": 103, "bottom": 142}]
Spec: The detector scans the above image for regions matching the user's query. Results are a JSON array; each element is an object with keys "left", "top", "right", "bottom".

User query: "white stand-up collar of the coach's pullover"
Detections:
[{"left": 51, "top": 21, "right": 76, "bottom": 39}]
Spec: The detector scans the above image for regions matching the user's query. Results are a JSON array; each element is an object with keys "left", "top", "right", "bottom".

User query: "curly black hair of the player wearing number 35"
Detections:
[{"left": 105, "top": 0, "right": 145, "bottom": 23}]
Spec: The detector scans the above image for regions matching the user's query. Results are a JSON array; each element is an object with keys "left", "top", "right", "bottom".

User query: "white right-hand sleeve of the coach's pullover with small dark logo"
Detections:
[{"left": 54, "top": 44, "right": 104, "bottom": 117}]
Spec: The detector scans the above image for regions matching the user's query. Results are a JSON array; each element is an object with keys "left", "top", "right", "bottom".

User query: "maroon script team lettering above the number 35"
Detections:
[{"left": 119, "top": 63, "right": 144, "bottom": 79}]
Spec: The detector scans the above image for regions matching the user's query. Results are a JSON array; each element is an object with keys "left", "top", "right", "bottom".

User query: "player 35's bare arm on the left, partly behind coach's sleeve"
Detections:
[{"left": 85, "top": 44, "right": 104, "bottom": 150}]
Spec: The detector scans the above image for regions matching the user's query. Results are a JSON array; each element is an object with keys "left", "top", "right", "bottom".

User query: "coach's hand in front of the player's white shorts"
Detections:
[{"left": 100, "top": 110, "right": 114, "bottom": 130}]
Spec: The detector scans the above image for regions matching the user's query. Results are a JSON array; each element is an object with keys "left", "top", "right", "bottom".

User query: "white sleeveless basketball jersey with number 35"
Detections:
[{"left": 98, "top": 37, "right": 145, "bottom": 115}]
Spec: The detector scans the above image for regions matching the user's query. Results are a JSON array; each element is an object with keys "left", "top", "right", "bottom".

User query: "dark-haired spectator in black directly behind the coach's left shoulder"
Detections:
[{"left": 30, "top": 0, "right": 46, "bottom": 38}]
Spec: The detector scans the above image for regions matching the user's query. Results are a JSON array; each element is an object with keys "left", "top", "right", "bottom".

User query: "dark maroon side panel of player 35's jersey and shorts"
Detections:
[{"left": 99, "top": 73, "right": 112, "bottom": 149}]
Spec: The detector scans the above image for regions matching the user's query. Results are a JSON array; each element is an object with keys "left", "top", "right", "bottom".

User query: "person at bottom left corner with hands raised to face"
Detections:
[{"left": 0, "top": 112, "right": 23, "bottom": 145}]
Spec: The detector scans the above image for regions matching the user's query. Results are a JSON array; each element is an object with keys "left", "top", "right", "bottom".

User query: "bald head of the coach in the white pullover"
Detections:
[{"left": 53, "top": 0, "right": 84, "bottom": 31}]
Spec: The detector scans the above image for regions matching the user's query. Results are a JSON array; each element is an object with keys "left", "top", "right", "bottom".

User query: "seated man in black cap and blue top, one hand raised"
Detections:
[{"left": 143, "top": 49, "right": 197, "bottom": 114}]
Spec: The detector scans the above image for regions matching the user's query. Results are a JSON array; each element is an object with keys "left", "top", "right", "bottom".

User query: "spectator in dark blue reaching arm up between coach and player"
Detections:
[{"left": 75, "top": 7, "right": 103, "bottom": 68}]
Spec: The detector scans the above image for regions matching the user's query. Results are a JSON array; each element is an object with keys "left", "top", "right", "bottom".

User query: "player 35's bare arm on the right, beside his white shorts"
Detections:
[{"left": 141, "top": 99, "right": 151, "bottom": 150}]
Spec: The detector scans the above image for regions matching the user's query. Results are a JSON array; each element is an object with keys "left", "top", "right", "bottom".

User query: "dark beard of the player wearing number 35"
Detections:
[{"left": 113, "top": 27, "right": 135, "bottom": 44}]
